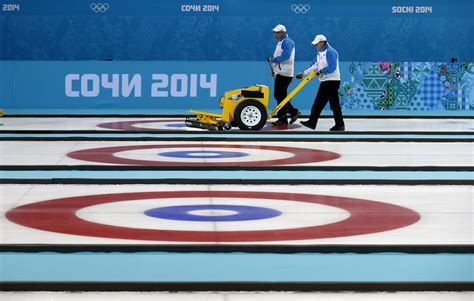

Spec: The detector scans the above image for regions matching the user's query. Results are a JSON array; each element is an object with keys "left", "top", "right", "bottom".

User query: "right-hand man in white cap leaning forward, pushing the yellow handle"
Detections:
[{"left": 296, "top": 34, "right": 345, "bottom": 131}]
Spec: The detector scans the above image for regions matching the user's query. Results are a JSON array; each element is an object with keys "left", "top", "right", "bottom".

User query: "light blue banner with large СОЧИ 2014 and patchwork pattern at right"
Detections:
[{"left": 0, "top": 61, "right": 474, "bottom": 115}]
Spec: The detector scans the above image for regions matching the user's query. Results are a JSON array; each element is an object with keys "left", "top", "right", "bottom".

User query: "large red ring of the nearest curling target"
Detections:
[{"left": 6, "top": 191, "right": 420, "bottom": 242}]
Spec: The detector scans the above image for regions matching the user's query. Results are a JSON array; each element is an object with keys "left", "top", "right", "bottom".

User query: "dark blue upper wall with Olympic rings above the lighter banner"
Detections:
[{"left": 0, "top": 0, "right": 474, "bottom": 62}]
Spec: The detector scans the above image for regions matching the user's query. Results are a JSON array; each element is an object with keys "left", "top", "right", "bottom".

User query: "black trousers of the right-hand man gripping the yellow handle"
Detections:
[{"left": 309, "top": 80, "right": 344, "bottom": 125}]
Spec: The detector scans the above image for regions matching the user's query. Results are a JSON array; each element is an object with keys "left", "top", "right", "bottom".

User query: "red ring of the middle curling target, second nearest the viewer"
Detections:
[{"left": 67, "top": 144, "right": 341, "bottom": 166}]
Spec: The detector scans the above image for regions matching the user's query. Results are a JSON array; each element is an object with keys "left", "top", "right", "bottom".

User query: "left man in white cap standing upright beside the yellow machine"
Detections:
[{"left": 272, "top": 24, "right": 300, "bottom": 126}]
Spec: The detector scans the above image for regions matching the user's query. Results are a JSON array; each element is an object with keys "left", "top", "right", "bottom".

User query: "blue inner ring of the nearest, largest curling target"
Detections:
[{"left": 145, "top": 205, "right": 281, "bottom": 222}]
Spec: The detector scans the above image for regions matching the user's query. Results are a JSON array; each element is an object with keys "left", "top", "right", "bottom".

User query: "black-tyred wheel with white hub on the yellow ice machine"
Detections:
[{"left": 234, "top": 99, "right": 267, "bottom": 131}]
